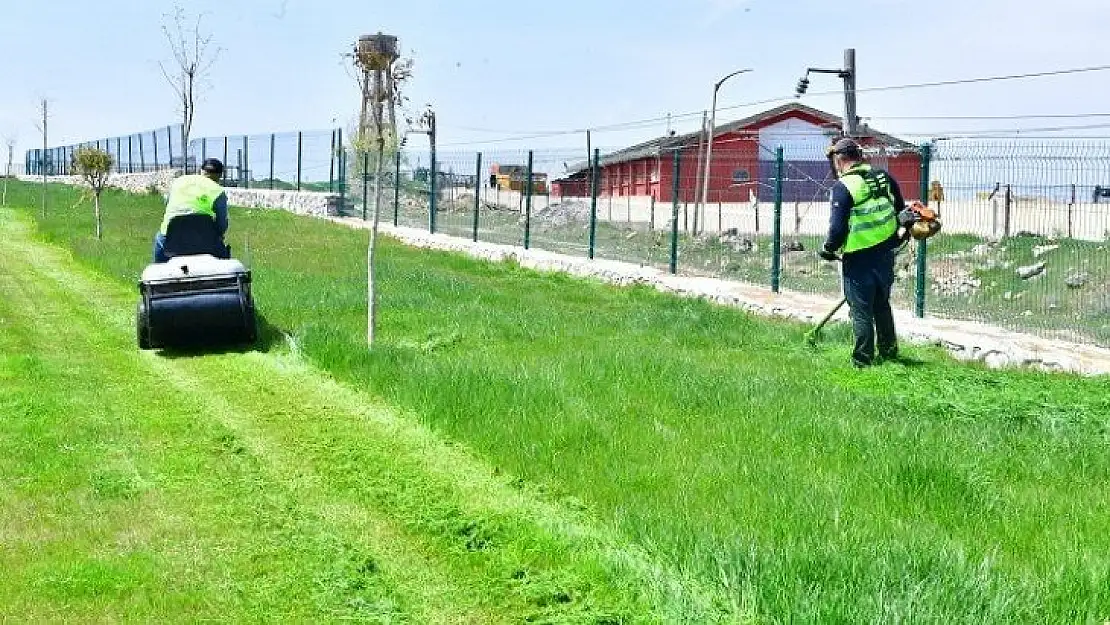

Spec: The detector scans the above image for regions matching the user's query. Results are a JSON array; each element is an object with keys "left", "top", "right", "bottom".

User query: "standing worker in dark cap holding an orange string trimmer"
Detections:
[{"left": 807, "top": 138, "right": 940, "bottom": 367}]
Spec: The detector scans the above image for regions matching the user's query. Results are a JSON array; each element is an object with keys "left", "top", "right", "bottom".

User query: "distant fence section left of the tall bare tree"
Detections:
[{"left": 23, "top": 124, "right": 186, "bottom": 175}]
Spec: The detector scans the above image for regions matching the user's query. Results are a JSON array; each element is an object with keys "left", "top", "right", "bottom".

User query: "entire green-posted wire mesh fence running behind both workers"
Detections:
[{"left": 22, "top": 119, "right": 1110, "bottom": 346}]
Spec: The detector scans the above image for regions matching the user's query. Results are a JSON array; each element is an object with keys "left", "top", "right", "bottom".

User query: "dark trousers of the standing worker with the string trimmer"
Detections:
[{"left": 842, "top": 249, "right": 898, "bottom": 366}]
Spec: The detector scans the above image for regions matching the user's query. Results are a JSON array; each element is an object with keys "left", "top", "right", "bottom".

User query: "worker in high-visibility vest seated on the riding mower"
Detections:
[{"left": 154, "top": 159, "right": 231, "bottom": 263}]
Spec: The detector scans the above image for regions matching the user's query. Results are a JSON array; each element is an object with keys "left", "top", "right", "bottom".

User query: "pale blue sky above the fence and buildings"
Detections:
[{"left": 0, "top": 0, "right": 1110, "bottom": 160}]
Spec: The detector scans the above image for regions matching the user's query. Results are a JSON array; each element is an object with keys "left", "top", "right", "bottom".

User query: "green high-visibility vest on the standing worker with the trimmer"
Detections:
[{"left": 840, "top": 163, "right": 898, "bottom": 254}]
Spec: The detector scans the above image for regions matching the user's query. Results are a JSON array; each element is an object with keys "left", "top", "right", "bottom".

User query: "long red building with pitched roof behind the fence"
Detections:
[{"left": 552, "top": 103, "right": 921, "bottom": 203}]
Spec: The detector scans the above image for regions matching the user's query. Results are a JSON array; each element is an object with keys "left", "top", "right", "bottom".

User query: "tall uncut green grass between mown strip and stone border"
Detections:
[{"left": 8, "top": 179, "right": 1110, "bottom": 623}]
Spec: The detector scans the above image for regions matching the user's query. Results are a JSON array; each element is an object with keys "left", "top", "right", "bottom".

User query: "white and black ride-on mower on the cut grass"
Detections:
[{"left": 135, "top": 214, "right": 258, "bottom": 350}]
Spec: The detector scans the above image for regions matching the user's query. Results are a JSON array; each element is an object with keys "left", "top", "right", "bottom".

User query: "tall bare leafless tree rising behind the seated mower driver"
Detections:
[{"left": 159, "top": 6, "right": 220, "bottom": 171}]
